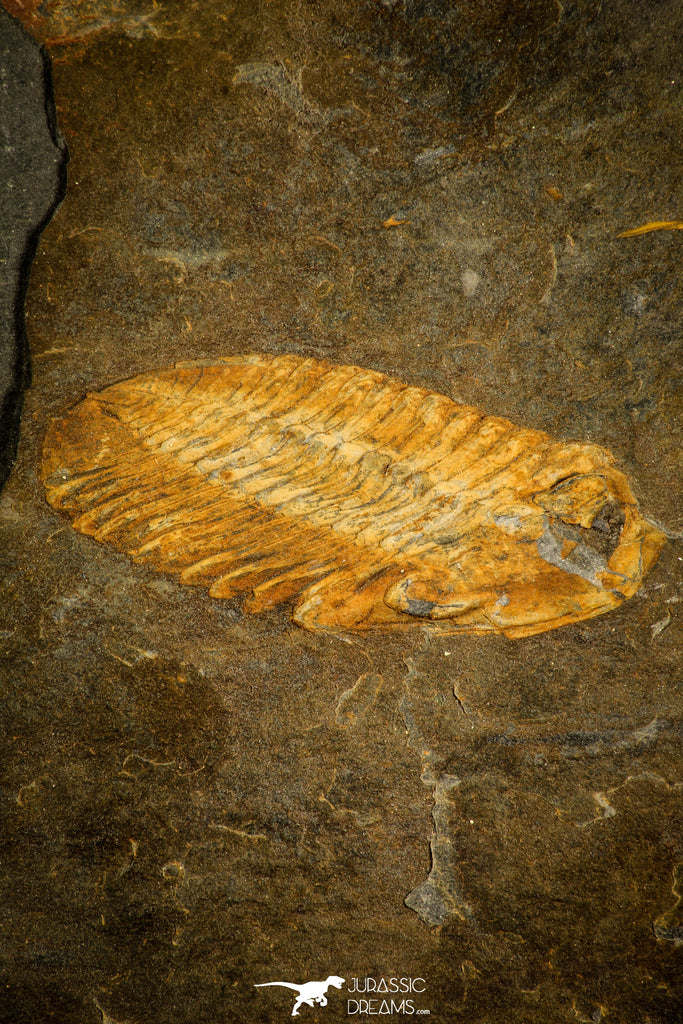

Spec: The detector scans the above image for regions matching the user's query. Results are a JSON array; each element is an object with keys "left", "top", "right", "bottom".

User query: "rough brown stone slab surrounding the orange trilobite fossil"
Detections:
[{"left": 0, "top": 0, "right": 683, "bottom": 1024}]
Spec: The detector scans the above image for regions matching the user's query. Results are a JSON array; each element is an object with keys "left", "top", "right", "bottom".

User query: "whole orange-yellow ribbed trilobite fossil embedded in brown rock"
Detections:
[{"left": 42, "top": 354, "right": 665, "bottom": 637}]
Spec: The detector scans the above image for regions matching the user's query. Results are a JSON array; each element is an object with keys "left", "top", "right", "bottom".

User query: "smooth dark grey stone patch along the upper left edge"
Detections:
[{"left": 0, "top": 7, "right": 66, "bottom": 487}]
